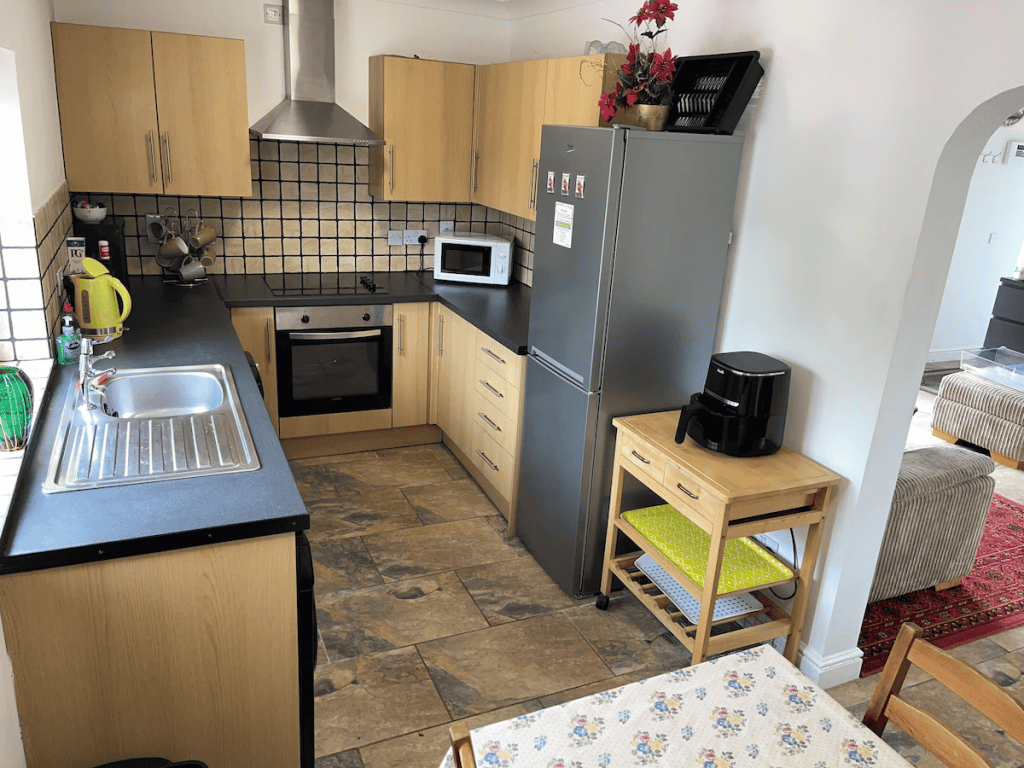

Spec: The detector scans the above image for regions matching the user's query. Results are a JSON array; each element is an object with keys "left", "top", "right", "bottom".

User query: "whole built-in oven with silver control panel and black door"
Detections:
[{"left": 274, "top": 304, "right": 393, "bottom": 417}]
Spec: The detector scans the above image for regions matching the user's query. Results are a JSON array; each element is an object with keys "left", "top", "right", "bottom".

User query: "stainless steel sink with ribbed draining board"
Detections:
[{"left": 43, "top": 365, "right": 260, "bottom": 494}]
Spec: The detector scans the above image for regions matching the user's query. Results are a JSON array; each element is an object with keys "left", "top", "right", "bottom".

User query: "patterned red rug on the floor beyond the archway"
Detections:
[{"left": 857, "top": 496, "right": 1024, "bottom": 677}]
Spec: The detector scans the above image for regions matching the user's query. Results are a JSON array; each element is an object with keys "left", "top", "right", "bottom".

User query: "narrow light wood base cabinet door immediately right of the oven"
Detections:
[{"left": 391, "top": 302, "right": 431, "bottom": 427}]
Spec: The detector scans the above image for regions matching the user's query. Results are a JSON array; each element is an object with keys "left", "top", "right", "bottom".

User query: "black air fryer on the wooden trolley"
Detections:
[{"left": 676, "top": 352, "right": 793, "bottom": 457}]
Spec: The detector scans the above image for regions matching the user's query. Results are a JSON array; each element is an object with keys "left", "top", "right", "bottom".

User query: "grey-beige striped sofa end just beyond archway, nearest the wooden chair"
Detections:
[{"left": 867, "top": 444, "right": 995, "bottom": 602}]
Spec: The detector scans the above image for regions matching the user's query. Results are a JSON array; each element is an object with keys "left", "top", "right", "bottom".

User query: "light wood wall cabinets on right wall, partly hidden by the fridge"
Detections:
[{"left": 473, "top": 54, "right": 624, "bottom": 220}]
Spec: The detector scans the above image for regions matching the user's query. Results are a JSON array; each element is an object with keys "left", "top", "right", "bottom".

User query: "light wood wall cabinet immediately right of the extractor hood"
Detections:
[{"left": 370, "top": 56, "right": 476, "bottom": 203}]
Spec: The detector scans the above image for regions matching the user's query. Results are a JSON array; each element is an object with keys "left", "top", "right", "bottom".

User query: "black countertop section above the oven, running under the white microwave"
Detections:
[{"left": 217, "top": 272, "right": 529, "bottom": 354}]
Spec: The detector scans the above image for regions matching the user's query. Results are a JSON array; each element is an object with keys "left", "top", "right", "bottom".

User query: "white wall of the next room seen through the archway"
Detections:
[{"left": 929, "top": 124, "right": 1024, "bottom": 360}]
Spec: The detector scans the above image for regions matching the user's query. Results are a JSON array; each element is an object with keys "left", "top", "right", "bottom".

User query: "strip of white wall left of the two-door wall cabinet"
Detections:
[{"left": 0, "top": 0, "right": 65, "bottom": 214}]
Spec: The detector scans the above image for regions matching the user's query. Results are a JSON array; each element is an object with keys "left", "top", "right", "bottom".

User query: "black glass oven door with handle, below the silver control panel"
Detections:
[{"left": 278, "top": 328, "right": 391, "bottom": 416}]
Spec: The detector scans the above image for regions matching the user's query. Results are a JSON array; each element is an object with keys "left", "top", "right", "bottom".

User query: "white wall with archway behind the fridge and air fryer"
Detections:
[{"left": 512, "top": 0, "right": 1024, "bottom": 684}]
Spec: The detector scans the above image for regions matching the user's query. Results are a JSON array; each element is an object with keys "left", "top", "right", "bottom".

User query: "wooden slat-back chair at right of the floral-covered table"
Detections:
[{"left": 864, "top": 622, "right": 1024, "bottom": 768}]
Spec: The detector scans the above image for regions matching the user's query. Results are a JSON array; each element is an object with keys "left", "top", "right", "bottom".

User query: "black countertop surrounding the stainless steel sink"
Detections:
[{"left": 0, "top": 278, "right": 309, "bottom": 573}]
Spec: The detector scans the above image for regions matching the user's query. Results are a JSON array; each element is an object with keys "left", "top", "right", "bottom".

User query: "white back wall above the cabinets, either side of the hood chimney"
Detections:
[{"left": 51, "top": 0, "right": 510, "bottom": 125}]
